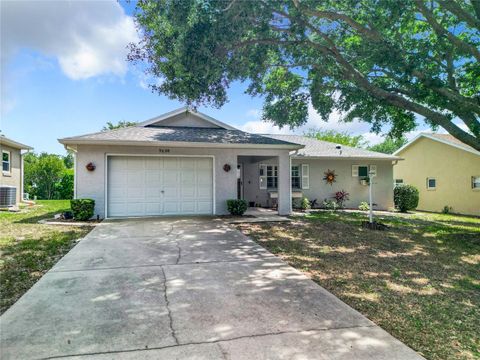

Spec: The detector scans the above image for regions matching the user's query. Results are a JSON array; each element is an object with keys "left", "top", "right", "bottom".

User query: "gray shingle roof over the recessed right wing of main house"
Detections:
[{"left": 265, "top": 134, "right": 401, "bottom": 160}]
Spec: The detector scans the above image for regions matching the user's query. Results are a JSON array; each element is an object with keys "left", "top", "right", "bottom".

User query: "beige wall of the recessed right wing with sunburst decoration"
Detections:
[{"left": 292, "top": 158, "right": 393, "bottom": 210}]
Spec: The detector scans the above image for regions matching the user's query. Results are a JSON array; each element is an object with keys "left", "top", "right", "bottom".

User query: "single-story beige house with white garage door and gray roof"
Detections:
[{"left": 59, "top": 108, "right": 399, "bottom": 217}]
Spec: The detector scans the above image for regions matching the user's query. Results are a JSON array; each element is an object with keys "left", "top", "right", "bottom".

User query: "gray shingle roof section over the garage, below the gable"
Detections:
[{"left": 60, "top": 126, "right": 297, "bottom": 147}]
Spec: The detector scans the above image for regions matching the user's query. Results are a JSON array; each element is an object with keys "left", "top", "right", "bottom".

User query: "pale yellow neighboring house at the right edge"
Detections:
[{"left": 393, "top": 133, "right": 480, "bottom": 216}]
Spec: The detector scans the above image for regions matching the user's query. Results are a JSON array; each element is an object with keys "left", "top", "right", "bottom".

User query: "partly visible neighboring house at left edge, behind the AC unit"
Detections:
[{"left": 0, "top": 135, "right": 32, "bottom": 207}]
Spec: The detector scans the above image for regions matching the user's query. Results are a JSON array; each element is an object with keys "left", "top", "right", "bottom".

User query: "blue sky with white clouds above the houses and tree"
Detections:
[{"left": 0, "top": 0, "right": 434, "bottom": 154}]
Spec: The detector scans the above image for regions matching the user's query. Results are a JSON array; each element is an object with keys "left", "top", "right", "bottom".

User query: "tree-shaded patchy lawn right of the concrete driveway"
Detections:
[{"left": 239, "top": 211, "right": 480, "bottom": 359}]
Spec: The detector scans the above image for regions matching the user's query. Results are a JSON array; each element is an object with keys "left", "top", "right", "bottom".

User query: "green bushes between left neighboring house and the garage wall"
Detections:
[{"left": 24, "top": 153, "right": 68, "bottom": 200}]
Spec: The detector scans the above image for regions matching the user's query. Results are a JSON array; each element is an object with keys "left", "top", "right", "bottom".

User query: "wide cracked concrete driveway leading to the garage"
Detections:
[{"left": 1, "top": 218, "right": 420, "bottom": 360}]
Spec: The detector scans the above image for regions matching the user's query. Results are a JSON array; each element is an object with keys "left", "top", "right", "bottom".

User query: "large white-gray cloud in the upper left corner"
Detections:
[{"left": 0, "top": 0, "right": 138, "bottom": 80}]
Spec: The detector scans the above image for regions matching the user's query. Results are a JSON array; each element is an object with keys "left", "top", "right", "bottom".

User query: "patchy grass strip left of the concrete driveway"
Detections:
[{"left": 0, "top": 200, "right": 91, "bottom": 313}]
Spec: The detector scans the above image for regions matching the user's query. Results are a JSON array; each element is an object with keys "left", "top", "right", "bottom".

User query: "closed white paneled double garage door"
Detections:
[{"left": 107, "top": 156, "right": 213, "bottom": 217}]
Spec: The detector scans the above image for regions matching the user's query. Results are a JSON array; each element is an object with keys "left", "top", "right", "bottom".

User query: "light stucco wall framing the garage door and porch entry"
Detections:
[{"left": 75, "top": 145, "right": 290, "bottom": 218}]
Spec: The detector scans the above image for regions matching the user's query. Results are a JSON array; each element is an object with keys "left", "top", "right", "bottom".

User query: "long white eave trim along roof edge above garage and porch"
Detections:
[{"left": 58, "top": 138, "right": 302, "bottom": 149}]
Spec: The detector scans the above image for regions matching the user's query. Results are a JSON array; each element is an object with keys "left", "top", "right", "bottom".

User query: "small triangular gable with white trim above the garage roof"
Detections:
[{"left": 137, "top": 107, "right": 235, "bottom": 130}]
